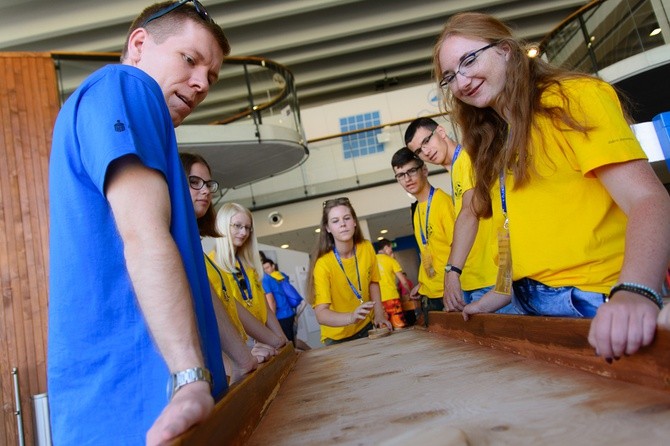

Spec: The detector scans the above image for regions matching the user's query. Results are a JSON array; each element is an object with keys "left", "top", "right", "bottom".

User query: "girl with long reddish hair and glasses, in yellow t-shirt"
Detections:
[{"left": 433, "top": 13, "right": 670, "bottom": 361}]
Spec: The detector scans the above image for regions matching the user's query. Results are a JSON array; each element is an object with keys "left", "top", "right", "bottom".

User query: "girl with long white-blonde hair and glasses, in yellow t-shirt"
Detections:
[{"left": 215, "top": 203, "right": 288, "bottom": 348}]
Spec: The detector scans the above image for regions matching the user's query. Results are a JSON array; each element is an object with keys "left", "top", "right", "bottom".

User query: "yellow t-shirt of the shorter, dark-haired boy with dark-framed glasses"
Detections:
[{"left": 414, "top": 188, "right": 455, "bottom": 298}]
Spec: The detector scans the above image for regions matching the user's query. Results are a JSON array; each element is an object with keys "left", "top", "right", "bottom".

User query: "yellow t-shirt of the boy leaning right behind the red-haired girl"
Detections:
[{"left": 451, "top": 150, "right": 498, "bottom": 291}]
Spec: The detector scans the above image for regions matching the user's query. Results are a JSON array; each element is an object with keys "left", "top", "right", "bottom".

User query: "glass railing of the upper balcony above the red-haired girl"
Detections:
[{"left": 540, "top": 0, "right": 670, "bottom": 74}]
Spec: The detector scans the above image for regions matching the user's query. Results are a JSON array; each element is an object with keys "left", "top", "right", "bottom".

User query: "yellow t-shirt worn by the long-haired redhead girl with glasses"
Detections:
[{"left": 492, "top": 79, "right": 646, "bottom": 293}]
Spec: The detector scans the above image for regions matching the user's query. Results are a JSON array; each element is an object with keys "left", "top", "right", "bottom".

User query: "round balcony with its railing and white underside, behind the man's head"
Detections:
[{"left": 52, "top": 52, "right": 308, "bottom": 188}]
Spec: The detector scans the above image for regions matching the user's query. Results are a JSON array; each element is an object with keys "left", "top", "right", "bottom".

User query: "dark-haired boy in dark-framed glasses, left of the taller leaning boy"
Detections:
[{"left": 391, "top": 147, "right": 454, "bottom": 325}]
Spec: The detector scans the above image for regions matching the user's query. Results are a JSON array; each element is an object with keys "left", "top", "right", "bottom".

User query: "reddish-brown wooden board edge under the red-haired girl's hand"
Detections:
[{"left": 428, "top": 312, "right": 670, "bottom": 391}]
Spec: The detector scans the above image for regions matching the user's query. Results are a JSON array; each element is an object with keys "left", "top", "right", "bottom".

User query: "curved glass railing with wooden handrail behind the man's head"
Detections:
[{"left": 52, "top": 52, "right": 305, "bottom": 137}]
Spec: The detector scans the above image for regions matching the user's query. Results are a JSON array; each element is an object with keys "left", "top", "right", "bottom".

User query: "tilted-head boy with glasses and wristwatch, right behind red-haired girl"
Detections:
[{"left": 405, "top": 118, "right": 517, "bottom": 317}]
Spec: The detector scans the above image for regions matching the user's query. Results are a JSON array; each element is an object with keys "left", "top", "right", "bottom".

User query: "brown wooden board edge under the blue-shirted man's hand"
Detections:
[{"left": 170, "top": 343, "right": 298, "bottom": 446}]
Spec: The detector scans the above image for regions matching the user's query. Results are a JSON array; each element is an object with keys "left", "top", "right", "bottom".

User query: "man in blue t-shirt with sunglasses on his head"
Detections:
[{"left": 47, "top": 0, "right": 230, "bottom": 445}]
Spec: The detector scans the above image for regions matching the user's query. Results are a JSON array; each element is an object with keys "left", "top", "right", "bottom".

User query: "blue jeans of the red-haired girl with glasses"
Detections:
[{"left": 512, "top": 278, "right": 605, "bottom": 318}]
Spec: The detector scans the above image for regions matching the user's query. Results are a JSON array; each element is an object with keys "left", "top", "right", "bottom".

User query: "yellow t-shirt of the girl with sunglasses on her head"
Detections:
[{"left": 314, "top": 240, "right": 379, "bottom": 342}]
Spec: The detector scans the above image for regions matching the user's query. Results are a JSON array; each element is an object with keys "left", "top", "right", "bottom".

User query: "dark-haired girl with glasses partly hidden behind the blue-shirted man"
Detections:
[{"left": 179, "top": 153, "right": 283, "bottom": 372}]
